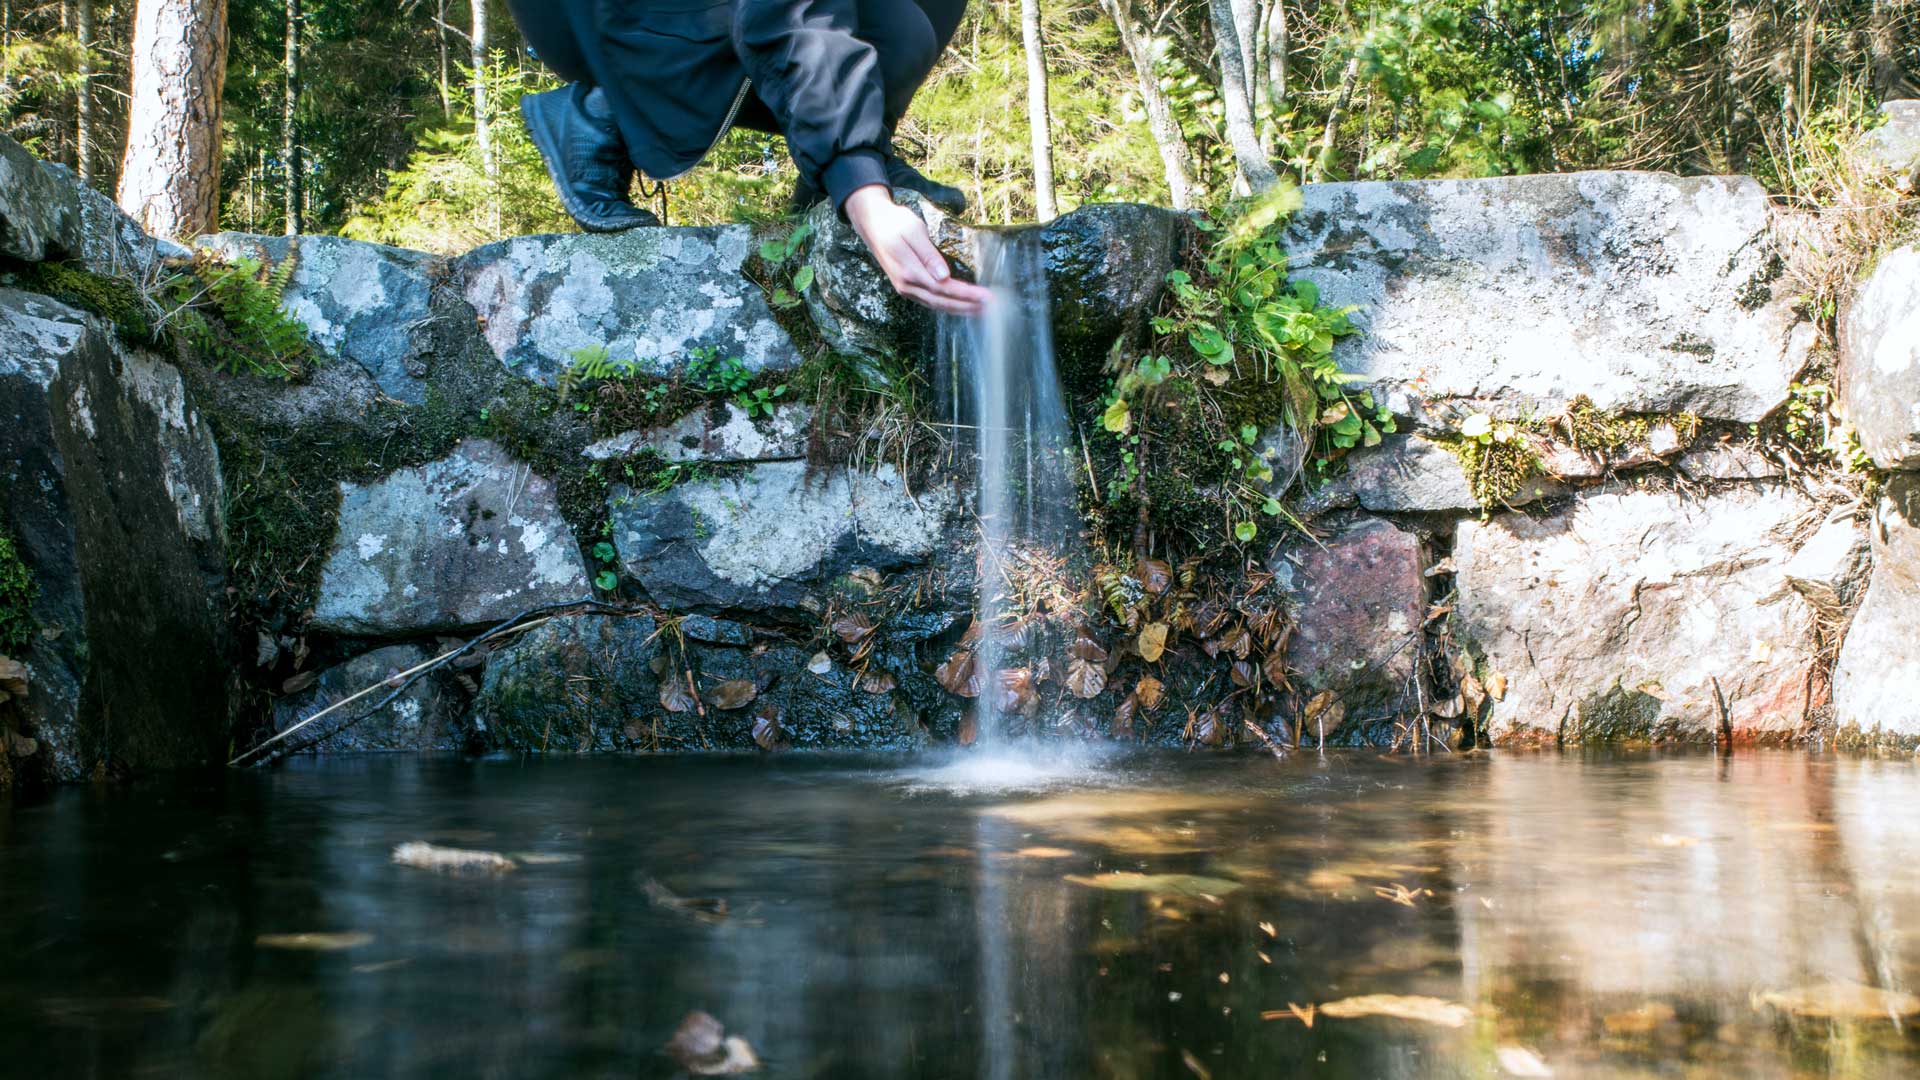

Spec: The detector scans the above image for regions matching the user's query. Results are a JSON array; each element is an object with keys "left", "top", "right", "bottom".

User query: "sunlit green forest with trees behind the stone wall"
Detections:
[{"left": 0, "top": 0, "right": 1920, "bottom": 252}]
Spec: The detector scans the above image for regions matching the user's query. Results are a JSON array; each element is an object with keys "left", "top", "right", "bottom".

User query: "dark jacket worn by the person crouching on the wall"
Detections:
[{"left": 511, "top": 0, "right": 894, "bottom": 206}]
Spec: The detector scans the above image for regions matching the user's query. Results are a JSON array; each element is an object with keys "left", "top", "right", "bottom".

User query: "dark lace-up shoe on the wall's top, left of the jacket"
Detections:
[{"left": 520, "top": 83, "right": 660, "bottom": 233}]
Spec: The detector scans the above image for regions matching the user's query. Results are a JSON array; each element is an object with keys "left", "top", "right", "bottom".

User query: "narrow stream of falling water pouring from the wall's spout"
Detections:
[{"left": 937, "top": 229, "right": 1077, "bottom": 745}]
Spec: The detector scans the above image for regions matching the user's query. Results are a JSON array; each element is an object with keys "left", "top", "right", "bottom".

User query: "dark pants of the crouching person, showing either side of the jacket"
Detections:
[{"left": 509, "top": 0, "right": 966, "bottom": 135}]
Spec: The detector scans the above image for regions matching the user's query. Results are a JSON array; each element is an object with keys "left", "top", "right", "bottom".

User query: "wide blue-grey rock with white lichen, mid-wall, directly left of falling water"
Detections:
[{"left": 607, "top": 461, "right": 956, "bottom": 615}]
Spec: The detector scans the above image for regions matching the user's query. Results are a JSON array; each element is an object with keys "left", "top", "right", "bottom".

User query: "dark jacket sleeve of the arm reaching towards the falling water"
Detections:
[{"left": 733, "top": 0, "right": 887, "bottom": 208}]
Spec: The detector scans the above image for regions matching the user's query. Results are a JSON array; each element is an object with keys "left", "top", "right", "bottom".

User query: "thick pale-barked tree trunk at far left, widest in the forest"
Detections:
[{"left": 119, "top": 0, "right": 227, "bottom": 240}]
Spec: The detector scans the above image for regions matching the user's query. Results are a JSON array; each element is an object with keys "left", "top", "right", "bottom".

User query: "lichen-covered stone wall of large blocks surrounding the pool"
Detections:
[{"left": 0, "top": 130, "right": 1920, "bottom": 778}]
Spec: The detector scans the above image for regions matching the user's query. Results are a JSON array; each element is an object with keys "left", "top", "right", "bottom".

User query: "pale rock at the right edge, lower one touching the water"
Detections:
[{"left": 1834, "top": 475, "right": 1920, "bottom": 746}]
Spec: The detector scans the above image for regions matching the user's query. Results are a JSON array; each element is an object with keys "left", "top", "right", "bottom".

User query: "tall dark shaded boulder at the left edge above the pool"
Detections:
[{"left": 0, "top": 288, "right": 232, "bottom": 780}]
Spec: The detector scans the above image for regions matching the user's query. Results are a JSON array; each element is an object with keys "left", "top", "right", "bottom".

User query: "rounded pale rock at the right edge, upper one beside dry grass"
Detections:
[{"left": 1839, "top": 244, "right": 1920, "bottom": 469}]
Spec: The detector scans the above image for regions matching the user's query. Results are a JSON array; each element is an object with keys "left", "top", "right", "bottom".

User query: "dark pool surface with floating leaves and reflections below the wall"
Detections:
[{"left": 0, "top": 753, "right": 1920, "bottom": 1080}]
